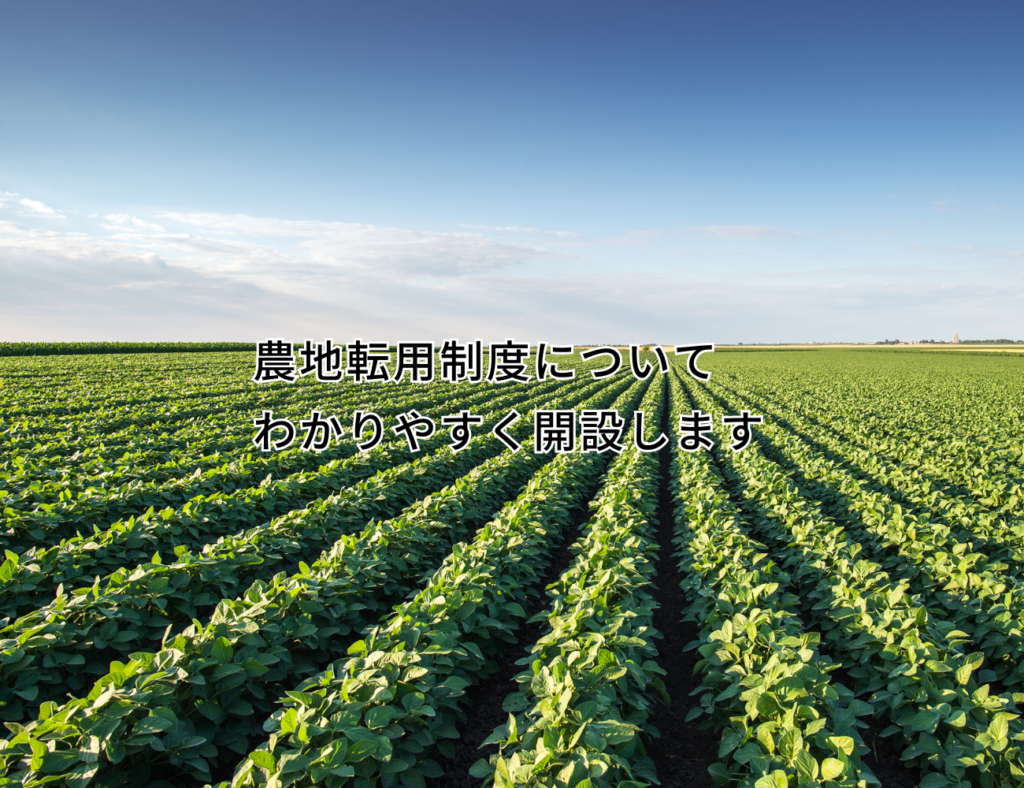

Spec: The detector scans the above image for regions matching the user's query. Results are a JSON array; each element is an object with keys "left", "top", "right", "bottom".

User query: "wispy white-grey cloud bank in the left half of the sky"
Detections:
[{"left": 0, "top": 205, "right": 568, "bottom": 336}]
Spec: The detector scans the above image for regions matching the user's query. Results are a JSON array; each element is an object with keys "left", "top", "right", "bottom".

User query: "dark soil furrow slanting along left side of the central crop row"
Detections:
[{"left": 426, "top": 458, "right": 603, "bottom": 788}]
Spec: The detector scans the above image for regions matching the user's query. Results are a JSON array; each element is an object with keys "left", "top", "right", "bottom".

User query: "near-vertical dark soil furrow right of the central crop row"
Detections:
[{"left": 646, "top": 388, "right": 720, "bottom": 788}]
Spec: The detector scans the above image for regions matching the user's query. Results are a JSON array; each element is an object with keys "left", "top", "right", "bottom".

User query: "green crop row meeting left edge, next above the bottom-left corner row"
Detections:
[{"left": 0, "top": 381, "right": 626, "bottom": 719}]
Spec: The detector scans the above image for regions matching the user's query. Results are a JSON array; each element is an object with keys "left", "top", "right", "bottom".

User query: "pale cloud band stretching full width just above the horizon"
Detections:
[{"left": 0, "top": 204, "right": 1024, "bottom": 344}]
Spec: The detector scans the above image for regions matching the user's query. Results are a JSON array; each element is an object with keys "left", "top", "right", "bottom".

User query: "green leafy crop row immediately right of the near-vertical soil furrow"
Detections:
[{"left": 673, "top": 370, "right": 878, "bottom": 788}]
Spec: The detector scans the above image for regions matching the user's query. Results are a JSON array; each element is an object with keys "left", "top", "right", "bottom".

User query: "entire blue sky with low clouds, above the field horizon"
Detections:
[{"left": 0, "top": 0, "right": 1024, "bottom": 344}]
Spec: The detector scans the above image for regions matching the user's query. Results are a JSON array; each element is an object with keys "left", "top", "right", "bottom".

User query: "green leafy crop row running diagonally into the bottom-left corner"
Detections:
[{"left": 0, "top": 423, "right": 581, "bottom": 781}]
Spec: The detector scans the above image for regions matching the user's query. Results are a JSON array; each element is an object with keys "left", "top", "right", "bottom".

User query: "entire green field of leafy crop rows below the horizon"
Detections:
[{"left": 0, "top": 348, "right": 1024, "bottom": 788}]
